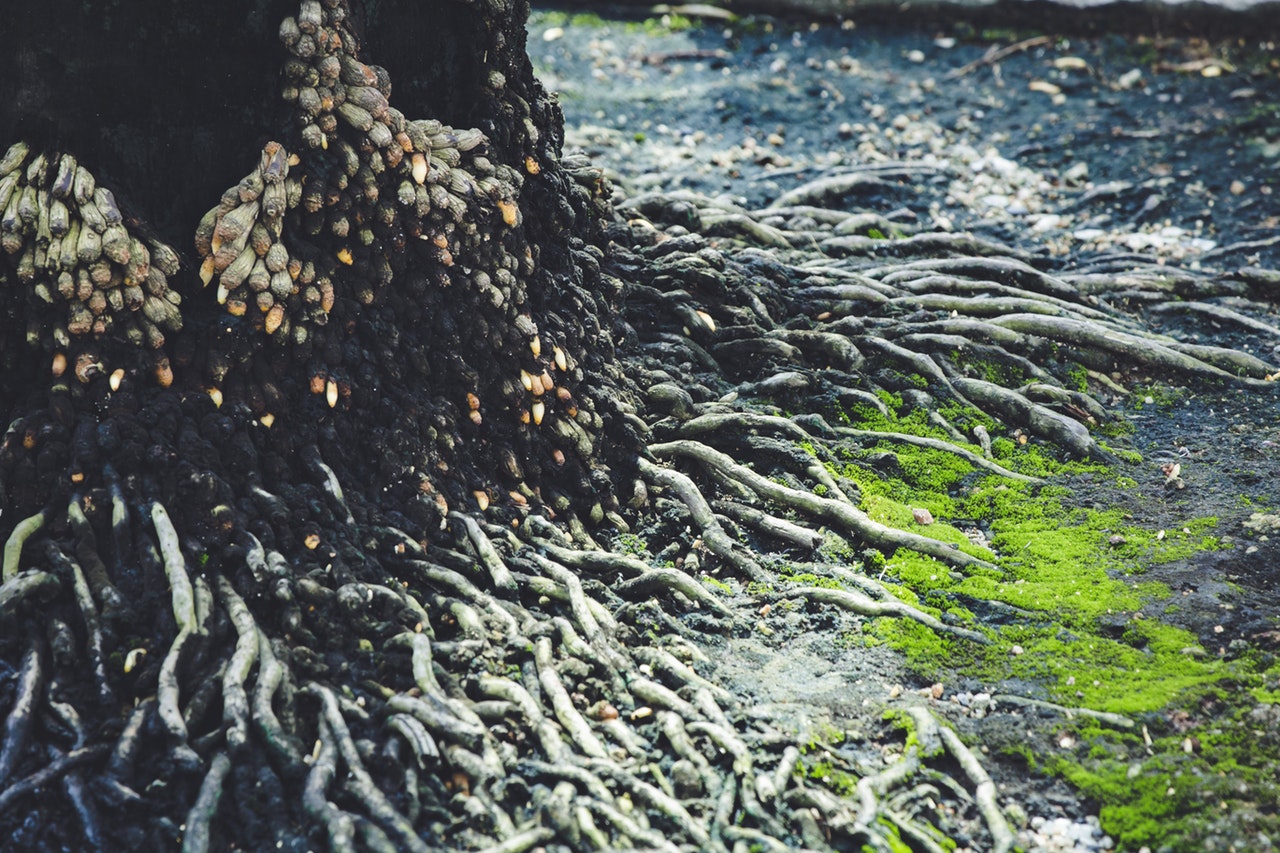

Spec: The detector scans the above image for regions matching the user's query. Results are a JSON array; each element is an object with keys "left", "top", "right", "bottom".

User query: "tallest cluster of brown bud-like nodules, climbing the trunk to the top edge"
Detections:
[{"left": 280, "top": 0, "right": 524, "bottom": 289}]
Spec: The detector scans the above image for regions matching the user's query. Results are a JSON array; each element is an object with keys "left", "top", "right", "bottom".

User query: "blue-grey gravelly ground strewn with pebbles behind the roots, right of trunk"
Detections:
[{"left": 530, "top": 4, "right": 1280, "bottom": 266}]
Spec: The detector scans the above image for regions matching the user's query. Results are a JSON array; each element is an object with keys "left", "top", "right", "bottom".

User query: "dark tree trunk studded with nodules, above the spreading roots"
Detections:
[{"left": 0, "top": 3, "right": 640, "bottom": 521}]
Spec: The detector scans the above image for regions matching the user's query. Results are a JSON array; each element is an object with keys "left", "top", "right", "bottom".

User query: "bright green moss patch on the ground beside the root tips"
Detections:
[{"left": 796, "top": 394, "right": 1280, "bottom": 849}]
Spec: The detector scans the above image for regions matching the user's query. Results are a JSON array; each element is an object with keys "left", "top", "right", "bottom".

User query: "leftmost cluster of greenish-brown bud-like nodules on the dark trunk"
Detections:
[{"left": 0, "top": 142, "right": 182, "bottom": 384}]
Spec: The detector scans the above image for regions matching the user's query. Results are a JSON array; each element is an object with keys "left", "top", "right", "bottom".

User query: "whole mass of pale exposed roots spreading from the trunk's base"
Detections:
[{"left": 0, "top": 3, "right": 1275, "bottom": 853}]
